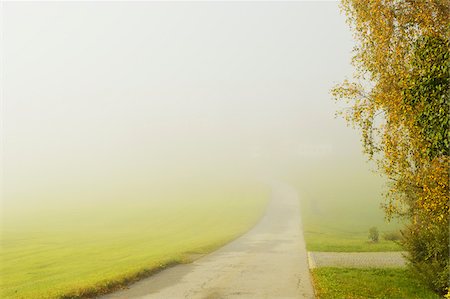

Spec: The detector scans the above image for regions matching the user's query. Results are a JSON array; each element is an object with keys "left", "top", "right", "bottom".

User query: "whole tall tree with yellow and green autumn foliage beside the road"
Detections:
[{"left": 332, "top": 0, "right": 450, "bottom": 293}]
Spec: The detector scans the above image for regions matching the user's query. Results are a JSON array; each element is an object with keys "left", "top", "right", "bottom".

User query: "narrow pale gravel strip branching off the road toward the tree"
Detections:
[{"left": 308, "top": 251, "right": 406, "bottom": 269}]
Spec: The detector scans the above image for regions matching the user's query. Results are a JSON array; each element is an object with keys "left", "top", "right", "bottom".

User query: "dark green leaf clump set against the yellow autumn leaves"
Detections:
[{"left": 403, "top": 36, "right": 450, "bottom": 160}]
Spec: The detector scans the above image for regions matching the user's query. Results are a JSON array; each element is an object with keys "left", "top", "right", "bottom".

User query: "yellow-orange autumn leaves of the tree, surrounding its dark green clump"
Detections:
[{"left": 332, "top": 0, "right": 450, "bottom": 222}]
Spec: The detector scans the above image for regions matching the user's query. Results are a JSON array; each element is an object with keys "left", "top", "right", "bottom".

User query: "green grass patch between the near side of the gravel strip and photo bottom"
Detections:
[{"left": 312, "top": 268, "right": 440, "bottom": 299}]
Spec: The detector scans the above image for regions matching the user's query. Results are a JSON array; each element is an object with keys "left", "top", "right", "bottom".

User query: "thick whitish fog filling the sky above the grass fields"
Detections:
[{"left": 1, "top": 2, "right": 369, "bottom": 214}]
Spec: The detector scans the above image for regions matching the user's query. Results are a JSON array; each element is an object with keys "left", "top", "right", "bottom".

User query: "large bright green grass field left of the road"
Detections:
[{"left": 0, "top": 184, "right": 269, "bottom": 298}]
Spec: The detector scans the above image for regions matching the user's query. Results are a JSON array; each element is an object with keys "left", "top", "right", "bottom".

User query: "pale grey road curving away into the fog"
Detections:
[{"left": 101, "top": 183, "right": 314, "bottom": 299}]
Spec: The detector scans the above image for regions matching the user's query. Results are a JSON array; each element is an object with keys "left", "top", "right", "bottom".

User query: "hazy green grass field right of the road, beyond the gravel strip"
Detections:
[{"left": 288, "top": 161, "right": 401, "bottom": 252}]
